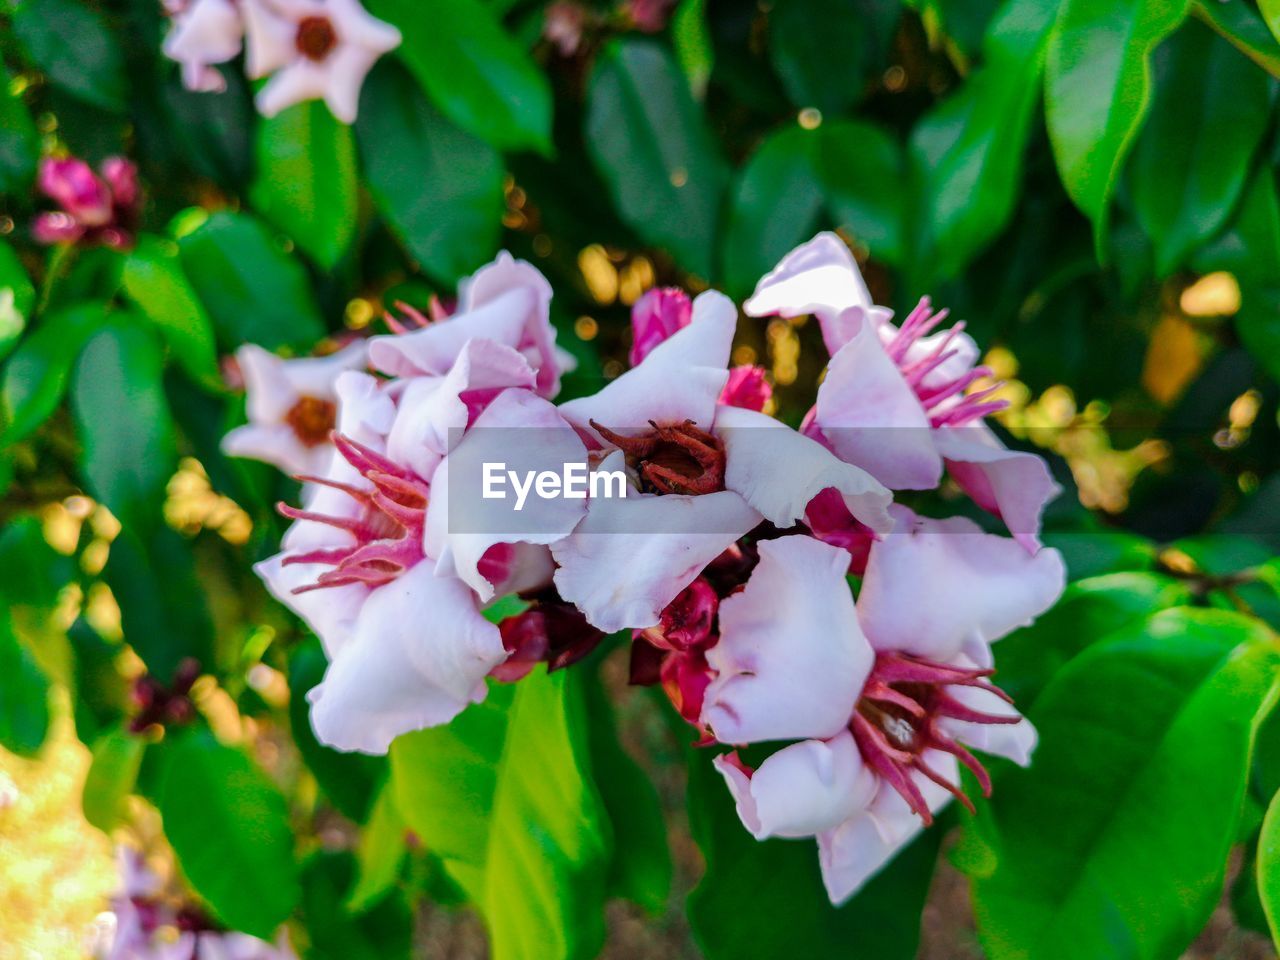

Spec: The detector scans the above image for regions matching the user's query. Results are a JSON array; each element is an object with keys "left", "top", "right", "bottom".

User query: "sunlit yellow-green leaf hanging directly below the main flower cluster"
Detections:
[{"left": 392, "top": 671, "right": 607, "bottom": 960}]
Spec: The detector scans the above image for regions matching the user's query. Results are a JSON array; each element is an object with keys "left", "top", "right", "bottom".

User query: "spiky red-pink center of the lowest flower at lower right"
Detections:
[{"left": 850, "top": 653, "right": 1021, "bottom": 824}]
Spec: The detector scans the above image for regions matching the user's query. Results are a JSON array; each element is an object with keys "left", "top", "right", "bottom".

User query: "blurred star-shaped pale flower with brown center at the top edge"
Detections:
[{"left": 243, "top": 0, "right": 401, "bottom": 123}]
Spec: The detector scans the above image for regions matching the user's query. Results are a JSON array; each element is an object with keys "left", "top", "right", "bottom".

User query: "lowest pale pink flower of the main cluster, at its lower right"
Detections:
[{"left": 701, "top": 507, "right": 1065, "bottom": 904}]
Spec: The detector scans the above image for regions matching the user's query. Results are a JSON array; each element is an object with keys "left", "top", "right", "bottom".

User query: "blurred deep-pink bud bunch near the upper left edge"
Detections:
[{"left": 32, "top": 156, "right": 141, "bottom": 250}]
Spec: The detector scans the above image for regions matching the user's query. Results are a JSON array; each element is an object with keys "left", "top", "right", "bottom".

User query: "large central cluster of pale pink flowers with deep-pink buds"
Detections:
[{"left": 227, "top": 234, "right": 1065, "bottom": 902}]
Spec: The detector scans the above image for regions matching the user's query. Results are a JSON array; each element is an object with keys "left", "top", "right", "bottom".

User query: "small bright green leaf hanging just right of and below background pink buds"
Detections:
[{"left": 123, "top": 234, "right": 223, "bottom": 390}]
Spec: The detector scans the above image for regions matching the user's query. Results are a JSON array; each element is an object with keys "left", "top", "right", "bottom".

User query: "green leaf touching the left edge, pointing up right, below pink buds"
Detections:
[{"left": 0, "top": 303, "right": 106, "bottom": 447}]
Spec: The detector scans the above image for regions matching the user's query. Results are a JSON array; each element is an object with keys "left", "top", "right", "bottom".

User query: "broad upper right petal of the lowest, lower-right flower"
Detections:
[{"left": 858, "top": 506, "right": 1066, "bottom": 662}]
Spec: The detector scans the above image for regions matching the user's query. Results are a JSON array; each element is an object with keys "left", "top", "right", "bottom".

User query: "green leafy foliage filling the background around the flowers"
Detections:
[{"left": 0, "top": 0, "right": 1280, "bottom": 960}]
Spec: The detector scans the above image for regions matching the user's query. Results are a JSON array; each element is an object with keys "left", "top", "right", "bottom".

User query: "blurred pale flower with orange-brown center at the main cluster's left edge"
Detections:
[{"left": 223, "top": 342, "right": 366, "bottom": 475}]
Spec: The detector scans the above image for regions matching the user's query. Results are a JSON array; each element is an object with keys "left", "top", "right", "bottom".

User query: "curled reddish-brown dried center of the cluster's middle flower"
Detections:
[{"left": 589, "top": 420, "right": 724, "bottom": 495}]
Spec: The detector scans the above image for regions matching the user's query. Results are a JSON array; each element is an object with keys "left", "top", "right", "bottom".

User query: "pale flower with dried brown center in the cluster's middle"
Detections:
[{"left": 552, "top": 292, "right": 891, "bottom": 640}]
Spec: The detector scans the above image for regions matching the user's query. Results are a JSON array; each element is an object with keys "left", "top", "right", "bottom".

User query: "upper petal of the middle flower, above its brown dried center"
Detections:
[{"left": 561, "top": 291, "right": 737, "bottom": 438}]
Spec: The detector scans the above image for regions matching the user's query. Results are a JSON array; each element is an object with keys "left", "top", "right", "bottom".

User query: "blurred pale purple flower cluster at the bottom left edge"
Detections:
[{"left": 93, "top": 846, "right": 297, "bottom": 960}]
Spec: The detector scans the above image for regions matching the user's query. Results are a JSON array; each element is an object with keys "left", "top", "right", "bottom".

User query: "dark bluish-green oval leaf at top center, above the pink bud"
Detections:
[{"left": 586, "top": 40, "right": 726, "bottom": 278}]
